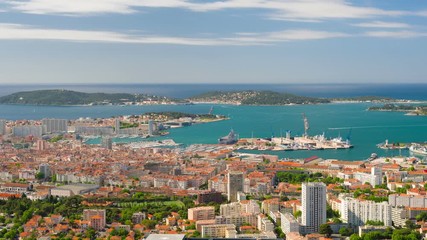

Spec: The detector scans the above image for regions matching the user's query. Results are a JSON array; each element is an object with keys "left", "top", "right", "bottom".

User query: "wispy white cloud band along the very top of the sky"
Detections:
[{"left": 6, "top": 0, "right": 408, "bottom": 21}]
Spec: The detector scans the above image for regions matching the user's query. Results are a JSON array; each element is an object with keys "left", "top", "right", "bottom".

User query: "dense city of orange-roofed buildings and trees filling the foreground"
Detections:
[{"left": 0, "top": 113, "right": 427, "bottom": 240}]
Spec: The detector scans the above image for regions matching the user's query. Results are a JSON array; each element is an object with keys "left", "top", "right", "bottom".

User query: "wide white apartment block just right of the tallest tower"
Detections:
[{"left": 340, "top": 197, "right": 392, "bottom": 226}]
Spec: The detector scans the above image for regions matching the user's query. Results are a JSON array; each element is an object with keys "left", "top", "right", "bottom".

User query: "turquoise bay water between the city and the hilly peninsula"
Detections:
[{"left": 0, "top": 103, "right": 427, "bottom": 160}]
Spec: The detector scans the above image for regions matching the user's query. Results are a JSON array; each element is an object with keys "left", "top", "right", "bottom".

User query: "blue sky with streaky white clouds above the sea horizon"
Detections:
[{"left": 0, "top": 0, "right": 427, "bottom": 84}]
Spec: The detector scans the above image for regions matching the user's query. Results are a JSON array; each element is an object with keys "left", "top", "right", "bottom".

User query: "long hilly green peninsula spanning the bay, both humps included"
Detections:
[{"left": 0, "top": 89, "right": 406, "bottom": 105}]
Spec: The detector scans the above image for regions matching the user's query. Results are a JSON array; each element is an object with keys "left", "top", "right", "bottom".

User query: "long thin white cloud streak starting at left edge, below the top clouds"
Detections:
[{"left": 0, "top": 23, "right": 348, "bottom": 46}]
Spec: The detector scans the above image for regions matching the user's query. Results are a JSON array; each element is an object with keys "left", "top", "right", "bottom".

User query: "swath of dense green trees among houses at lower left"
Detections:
[{"left": 0, "top": 192, "right": 199, "bottom": 240}]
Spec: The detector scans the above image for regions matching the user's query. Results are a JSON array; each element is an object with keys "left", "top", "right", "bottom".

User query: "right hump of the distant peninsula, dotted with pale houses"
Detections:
[{"left": 189, "top": 91, "right": 330, "bottom": 105}]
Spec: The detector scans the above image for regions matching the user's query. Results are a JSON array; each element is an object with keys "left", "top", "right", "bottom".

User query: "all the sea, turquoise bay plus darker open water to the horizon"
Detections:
[{"left": 0, "top": 84, "right": 427, "bottom": 161}]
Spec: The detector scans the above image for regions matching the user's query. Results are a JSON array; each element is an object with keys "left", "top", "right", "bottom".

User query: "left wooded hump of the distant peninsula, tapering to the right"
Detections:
[{"left": 0, "top": 89, "right": 184, "bottom": 105}]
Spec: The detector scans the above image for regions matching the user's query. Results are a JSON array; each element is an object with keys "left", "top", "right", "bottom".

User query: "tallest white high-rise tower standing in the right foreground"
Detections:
[{"left": 301, "top": 182, "right": 326, "bottom": 233}]
